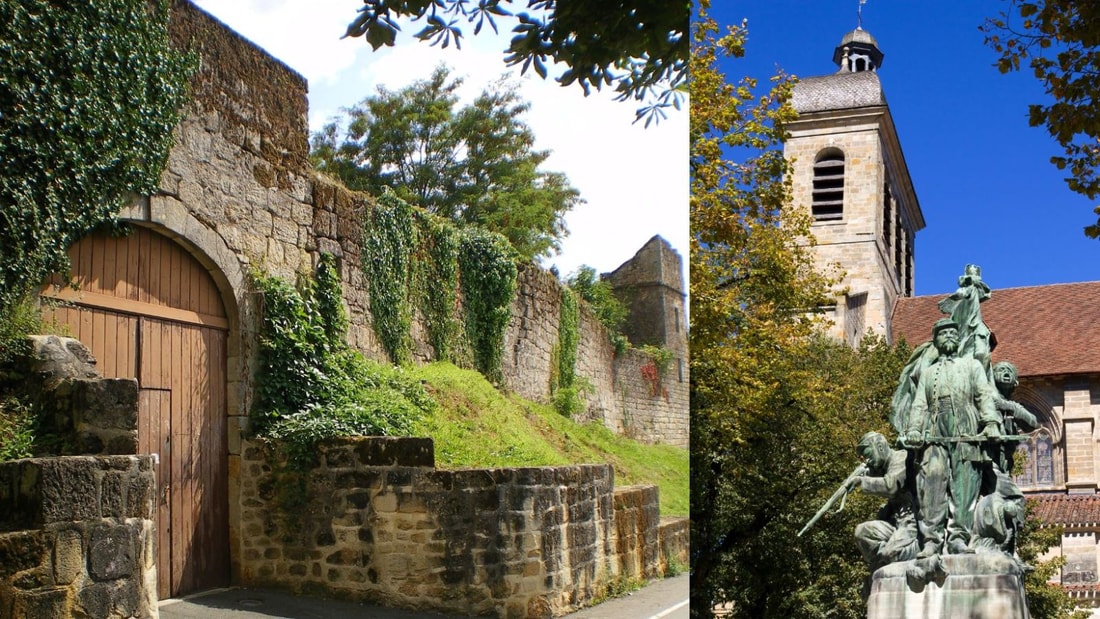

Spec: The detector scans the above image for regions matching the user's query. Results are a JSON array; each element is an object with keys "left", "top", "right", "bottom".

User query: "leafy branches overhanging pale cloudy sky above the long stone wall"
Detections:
[{"left": 344, "top": 0, "right": 691, "bottom": 124}]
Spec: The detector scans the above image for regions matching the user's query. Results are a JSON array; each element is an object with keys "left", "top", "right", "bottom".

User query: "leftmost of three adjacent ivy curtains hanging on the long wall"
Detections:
[{"left": 363, "top": 190, "right": 417, "bottom": 364}]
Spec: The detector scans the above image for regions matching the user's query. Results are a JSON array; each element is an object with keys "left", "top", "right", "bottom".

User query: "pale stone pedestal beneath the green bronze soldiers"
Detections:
[{"left": 867, "top": 553, "right": 1031, "bottom": 619}]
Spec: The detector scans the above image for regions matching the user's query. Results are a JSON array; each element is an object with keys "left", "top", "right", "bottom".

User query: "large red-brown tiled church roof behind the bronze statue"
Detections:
[{"left": 892, "top": 281, "right": 1100, "bottom": 376}]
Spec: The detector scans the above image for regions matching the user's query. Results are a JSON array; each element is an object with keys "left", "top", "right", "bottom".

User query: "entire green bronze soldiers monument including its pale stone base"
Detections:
[{"left": 799, "top": 265, "right": 1038, "bottom": 619}]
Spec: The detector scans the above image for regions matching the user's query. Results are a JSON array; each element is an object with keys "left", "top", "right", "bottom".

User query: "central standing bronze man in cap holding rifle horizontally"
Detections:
[{"left": 901, "top": 318, "right": 1003, "bottom": 557}]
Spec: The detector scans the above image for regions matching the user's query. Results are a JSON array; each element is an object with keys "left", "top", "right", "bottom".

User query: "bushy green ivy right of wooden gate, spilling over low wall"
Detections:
[{"left": 252, "top": 256, "right": 435, "bottom": 466}]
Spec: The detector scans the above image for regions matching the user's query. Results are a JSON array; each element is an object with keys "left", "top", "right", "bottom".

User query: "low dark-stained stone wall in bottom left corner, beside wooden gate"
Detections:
[{"left": 0, "top": 456, "right": 157, "bottom": 619}]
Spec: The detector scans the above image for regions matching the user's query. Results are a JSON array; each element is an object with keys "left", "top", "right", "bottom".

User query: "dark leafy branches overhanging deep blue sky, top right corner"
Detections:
[{"left": 981, "top": 0, "right": 1100, "bottom": 239}]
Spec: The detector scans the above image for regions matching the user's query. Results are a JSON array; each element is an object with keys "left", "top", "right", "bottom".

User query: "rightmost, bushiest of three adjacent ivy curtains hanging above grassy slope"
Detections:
[{"left": 459, "top": 228, "right": 517, "bottom": 383}]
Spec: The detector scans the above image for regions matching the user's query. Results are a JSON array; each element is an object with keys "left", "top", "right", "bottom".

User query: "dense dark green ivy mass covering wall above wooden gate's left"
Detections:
[{"left": 0, "top": 0, "right": 194, "bottom": 312}]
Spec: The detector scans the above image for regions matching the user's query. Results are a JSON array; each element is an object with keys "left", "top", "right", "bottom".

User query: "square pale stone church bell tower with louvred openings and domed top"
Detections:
[{"left": 784, "top": 27, "right": 924, "bottom": 345}]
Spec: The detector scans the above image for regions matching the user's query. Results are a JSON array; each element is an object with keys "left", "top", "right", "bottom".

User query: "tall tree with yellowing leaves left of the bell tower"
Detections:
[{"left": 690, "top": 2, "right": 905, "bottom": 618}]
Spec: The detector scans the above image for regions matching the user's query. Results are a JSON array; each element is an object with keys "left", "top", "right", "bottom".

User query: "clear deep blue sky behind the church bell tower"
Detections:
[{"left": 712, "top": 0, "right": 1100, "bottom": 295}]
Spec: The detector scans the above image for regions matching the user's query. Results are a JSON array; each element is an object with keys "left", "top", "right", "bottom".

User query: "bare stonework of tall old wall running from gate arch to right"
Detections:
[{"left": 140, "top": 0, "right": 688, "bottom": 455}]
